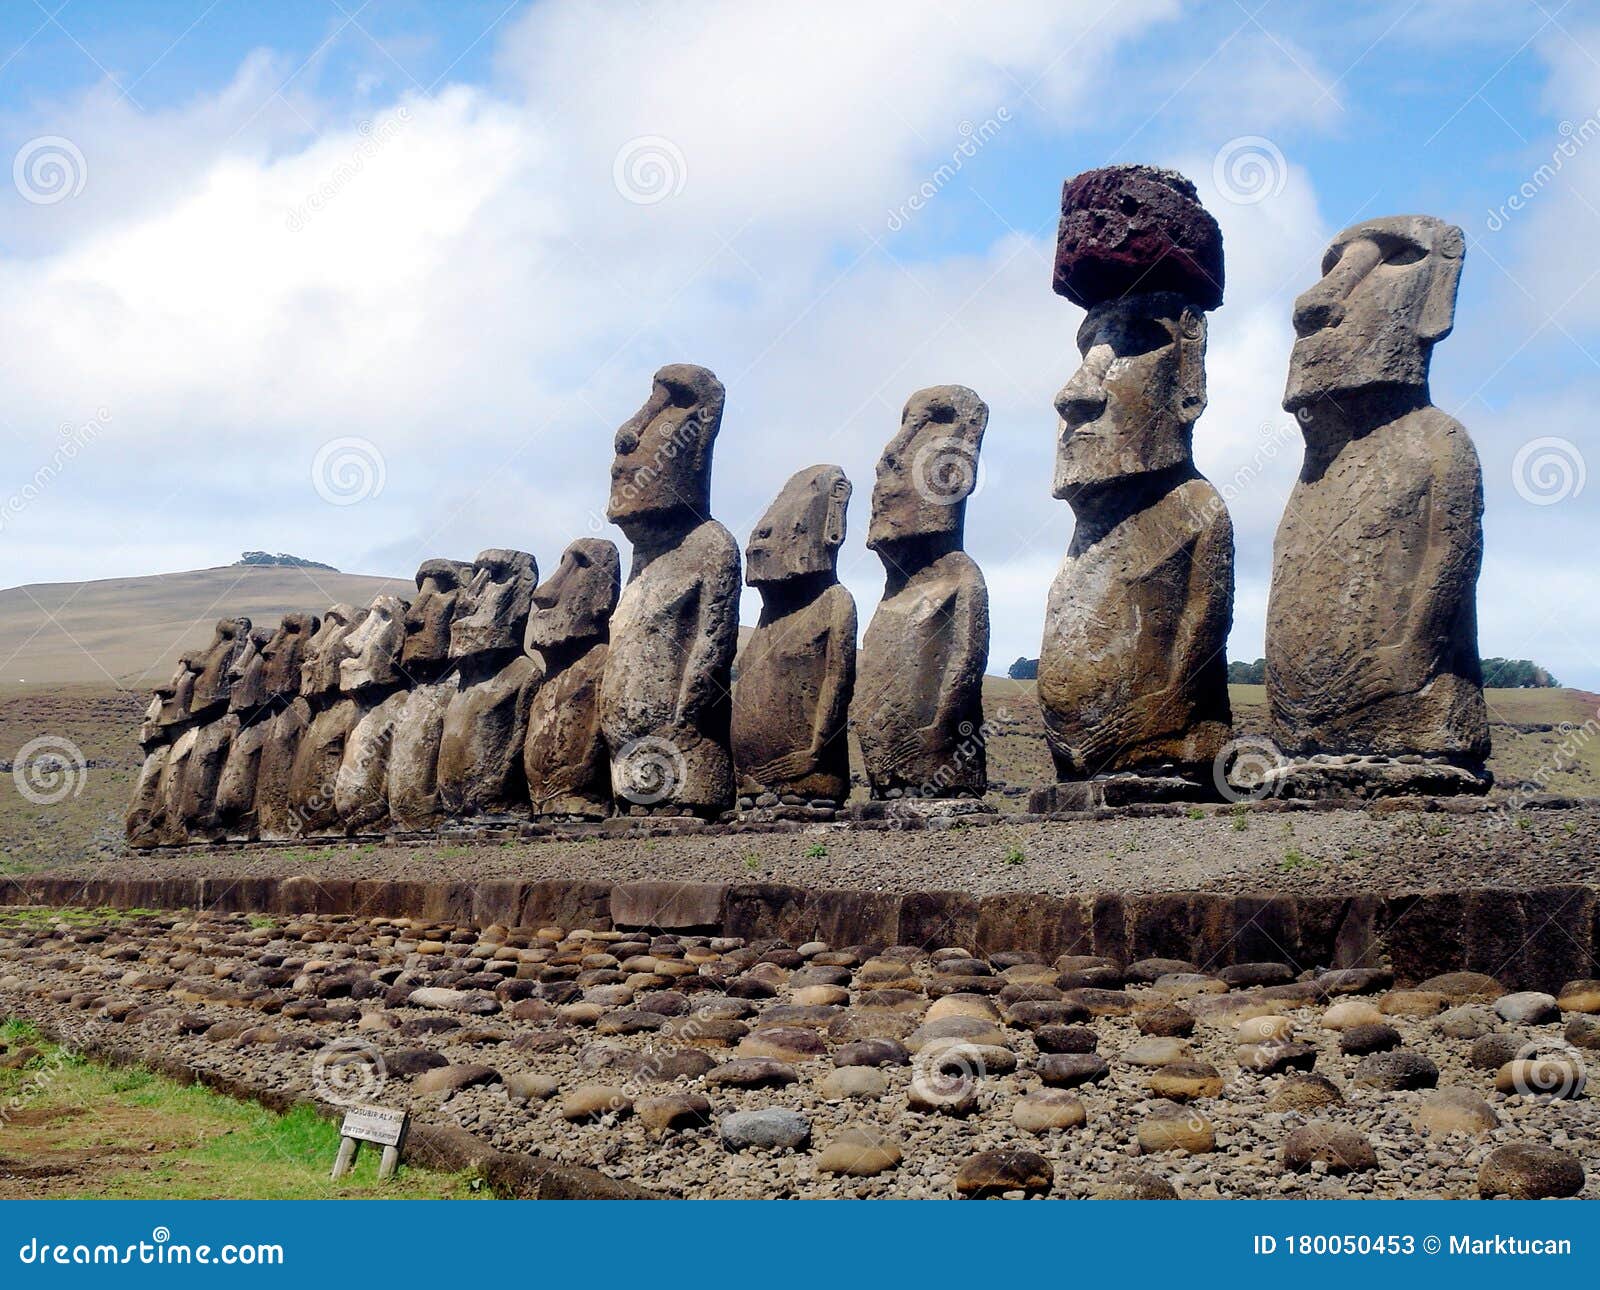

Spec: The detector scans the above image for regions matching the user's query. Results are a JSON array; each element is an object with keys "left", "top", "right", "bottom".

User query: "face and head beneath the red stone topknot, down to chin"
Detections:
[{"left": 1054, "top": 291, "right": 1206, "bottom": 498}]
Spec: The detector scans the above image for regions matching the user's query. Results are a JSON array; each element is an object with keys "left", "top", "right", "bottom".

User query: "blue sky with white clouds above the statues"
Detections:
[{"left": 0, "top": 0, "right": 1600, "bottom": 688}]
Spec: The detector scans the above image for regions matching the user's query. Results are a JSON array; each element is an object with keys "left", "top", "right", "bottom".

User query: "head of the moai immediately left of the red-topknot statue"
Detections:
[{"left": 867, "top": 386, "right": 989, "bottom": 551}]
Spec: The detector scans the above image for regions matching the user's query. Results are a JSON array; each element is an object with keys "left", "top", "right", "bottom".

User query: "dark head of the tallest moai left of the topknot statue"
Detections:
[{"left": 606, "top": 363, "right": 725, "bottom": 533}]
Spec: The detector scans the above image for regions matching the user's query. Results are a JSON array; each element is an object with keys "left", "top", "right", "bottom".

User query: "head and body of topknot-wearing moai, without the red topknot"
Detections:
[{"left": 1038, "top": 278, "right": 1234, "bottom": 797}]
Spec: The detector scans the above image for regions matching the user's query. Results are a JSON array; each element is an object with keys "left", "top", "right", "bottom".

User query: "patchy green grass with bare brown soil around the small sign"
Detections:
[{"left": 0, "top": 1020, "right": 486, "bottom": 1200}]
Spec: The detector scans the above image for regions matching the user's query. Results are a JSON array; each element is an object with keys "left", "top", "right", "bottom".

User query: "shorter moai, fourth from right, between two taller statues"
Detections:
[{"left": 733, "top": 466, "right": 856, "bottom": 810}]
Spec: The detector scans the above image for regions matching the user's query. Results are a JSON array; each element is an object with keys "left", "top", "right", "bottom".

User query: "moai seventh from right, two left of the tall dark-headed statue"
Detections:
[{"left": 438, "top": 549, "right": 539, "bottom": 818}]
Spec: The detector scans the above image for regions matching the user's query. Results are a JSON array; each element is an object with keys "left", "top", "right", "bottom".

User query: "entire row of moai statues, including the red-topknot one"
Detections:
[{"left": 128, "top": 166, "right": 1490, "bottom": 847}]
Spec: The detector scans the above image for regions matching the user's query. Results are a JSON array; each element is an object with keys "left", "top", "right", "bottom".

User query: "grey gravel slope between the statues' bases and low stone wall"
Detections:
[{"left": 51, "top": 803, "right": 1600, "bottom": 895}]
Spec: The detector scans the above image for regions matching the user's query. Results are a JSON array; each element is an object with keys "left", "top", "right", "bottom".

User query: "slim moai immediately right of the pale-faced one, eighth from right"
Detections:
[{"left": 389, "top": 560, "right": 472, "bottom": 831}]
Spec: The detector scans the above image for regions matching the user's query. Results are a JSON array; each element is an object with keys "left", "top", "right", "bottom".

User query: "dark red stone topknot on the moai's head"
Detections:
[{"left": 1054, "top": 165, "right": 1222, "bottom": 309}]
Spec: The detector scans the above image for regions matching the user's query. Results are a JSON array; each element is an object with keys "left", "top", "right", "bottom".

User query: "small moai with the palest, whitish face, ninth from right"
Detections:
[{"left": 333, "top": 595, "right": 406, "bottom": 834}]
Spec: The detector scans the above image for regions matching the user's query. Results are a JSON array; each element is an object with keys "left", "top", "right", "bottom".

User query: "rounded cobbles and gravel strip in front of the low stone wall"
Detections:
[{"left": 0, "top": 909, "right": 1600, "bottom": 1197}]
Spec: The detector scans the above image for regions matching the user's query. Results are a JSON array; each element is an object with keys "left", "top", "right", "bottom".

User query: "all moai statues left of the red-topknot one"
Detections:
[{"left": 126, "top": 367, "right": 989, "bottom": 847}]
